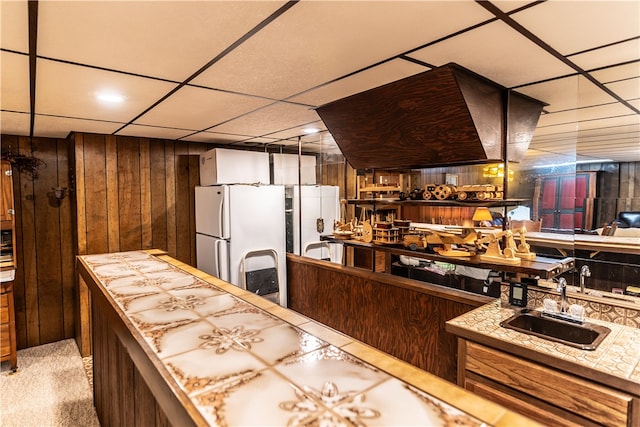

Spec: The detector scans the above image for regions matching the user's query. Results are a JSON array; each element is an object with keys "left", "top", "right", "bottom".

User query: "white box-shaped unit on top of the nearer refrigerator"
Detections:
[{"left": 200, "top": 148, "right": 270, "bottom": 185}]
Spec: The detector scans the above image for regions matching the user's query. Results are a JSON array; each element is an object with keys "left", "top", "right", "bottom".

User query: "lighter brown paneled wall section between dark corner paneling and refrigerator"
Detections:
[{"left": 71, "top": 133, "right": 210, "bottom": 265}]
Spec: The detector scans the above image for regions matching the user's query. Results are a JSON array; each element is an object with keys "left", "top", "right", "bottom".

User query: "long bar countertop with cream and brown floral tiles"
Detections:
[{"left": 78, "top": 251, "right": 534, "bottom": 426}]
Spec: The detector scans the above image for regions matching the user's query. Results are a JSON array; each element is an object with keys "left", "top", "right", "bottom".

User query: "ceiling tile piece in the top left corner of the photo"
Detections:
[{"left": 0, "top": 0, "right": 29, "bottom": 53}]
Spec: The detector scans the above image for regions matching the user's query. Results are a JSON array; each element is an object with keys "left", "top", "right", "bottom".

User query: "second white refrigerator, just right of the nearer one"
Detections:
[{"left": 286, "top": 185, "right": 342, "bottom": 263}]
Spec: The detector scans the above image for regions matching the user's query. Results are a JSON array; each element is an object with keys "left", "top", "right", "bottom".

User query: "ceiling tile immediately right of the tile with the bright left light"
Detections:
[{"left": 136, "top": 86, "right": 273, "bottom": 130}]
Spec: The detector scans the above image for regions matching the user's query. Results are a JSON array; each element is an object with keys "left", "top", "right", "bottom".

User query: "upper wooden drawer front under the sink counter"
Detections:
[{"left": 465, "top": 342, "right": 633, "bottom": 426}]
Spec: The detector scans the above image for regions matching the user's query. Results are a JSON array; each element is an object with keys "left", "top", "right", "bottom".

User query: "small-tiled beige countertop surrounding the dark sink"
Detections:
[{"left": 447, "top": 300, "right": 640, "bottom": 395}]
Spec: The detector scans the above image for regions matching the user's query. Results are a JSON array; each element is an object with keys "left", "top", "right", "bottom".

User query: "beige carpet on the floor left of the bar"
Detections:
[{"left": 0, "top": 339, "right": 100, "bottom": 427}]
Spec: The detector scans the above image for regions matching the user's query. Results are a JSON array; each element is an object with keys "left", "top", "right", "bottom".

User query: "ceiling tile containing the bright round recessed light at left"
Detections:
[{"left": 36, "top": 59, "right": 176, "bottom": 123}]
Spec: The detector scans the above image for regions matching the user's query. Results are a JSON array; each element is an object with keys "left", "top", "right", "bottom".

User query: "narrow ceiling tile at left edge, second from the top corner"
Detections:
[{"left": 0, "top": 52, "right": 30, "bottom": 112}]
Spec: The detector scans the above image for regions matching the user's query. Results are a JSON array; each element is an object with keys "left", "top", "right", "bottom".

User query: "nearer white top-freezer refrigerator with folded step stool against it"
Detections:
[{"left": 195, "top": 184, "right": 287, "bottom": 306}]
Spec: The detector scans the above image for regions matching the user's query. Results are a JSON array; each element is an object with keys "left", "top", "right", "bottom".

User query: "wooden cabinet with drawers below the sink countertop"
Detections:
[{"left": 458, "top": 339, "right": 640, "bottom": 426}]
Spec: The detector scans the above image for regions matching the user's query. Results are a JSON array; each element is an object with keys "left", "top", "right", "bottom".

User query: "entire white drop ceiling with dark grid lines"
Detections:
[{"left": 0, "top": 0, "right": 640, "bottom": 169}]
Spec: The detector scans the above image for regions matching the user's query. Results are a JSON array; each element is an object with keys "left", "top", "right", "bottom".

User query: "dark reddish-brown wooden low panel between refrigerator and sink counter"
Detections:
[{"left": 287, "top": 255, "right": 489, "bottom": 382}]
